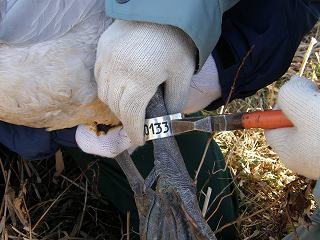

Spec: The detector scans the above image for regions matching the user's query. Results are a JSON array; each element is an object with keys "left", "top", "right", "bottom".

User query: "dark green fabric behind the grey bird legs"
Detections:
[{"left": 63, "top": 133, "right": 238, "bottom": 240}]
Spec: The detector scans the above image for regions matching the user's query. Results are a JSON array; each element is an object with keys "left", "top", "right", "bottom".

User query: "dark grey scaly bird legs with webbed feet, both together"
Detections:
[{"left": 116, "top": 90, "right": 216, "bottom": 240}]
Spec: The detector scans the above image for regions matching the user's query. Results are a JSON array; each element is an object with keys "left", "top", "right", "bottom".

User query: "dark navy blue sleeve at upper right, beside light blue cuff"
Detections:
[{"left": 208, "top": 0, "right": 320, "bottom": 109}]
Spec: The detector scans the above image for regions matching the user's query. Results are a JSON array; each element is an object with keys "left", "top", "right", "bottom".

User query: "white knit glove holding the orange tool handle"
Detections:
[{"left": 265, "top": 76, "right": 320, "bottom": 179}]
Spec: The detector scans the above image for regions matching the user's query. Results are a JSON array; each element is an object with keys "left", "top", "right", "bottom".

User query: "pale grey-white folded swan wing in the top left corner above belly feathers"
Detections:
[{"left": 0, "top": 0, "right": 104, "bottom": 45}]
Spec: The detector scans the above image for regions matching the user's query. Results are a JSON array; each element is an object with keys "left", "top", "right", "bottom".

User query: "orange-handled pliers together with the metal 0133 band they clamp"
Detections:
[{"left": 144, "top": 110, "right": 293, "bottom": 141}]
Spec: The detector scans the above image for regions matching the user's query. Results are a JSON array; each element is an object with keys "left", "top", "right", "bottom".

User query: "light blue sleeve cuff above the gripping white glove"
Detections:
[{"left": 105, "top": 0, "right": 239, "bottom": 70}]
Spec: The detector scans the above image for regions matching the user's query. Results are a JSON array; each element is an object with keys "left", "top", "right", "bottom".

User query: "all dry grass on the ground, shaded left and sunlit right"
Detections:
[{"left": 0, "top": 23, "right": 320, "bottom": 239}]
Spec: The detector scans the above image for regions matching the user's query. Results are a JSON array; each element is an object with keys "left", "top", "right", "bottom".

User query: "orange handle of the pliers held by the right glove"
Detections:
[{"left": 242, "top": 110, "right": 293, "bottom": 129}]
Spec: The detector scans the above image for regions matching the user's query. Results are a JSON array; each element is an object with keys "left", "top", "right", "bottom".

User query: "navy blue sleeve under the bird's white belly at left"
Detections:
[{"left": 0, "top": 121, "right": 77, "bottom": 160}]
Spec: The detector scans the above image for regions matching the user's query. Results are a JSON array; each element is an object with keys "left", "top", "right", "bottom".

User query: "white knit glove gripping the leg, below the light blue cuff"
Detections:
[{"left": 95, "top": 20, "right": 196, "bottom": 145}]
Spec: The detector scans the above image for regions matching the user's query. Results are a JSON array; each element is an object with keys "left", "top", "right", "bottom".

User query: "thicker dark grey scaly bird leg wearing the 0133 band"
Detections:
[{"left": 146, "top": 88, "right": 216, "bottom": 239}]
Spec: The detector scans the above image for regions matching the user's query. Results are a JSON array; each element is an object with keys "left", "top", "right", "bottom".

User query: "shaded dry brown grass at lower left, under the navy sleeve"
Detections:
[{"left": 0, "top": 147, "right": 124, "bottom": 240}]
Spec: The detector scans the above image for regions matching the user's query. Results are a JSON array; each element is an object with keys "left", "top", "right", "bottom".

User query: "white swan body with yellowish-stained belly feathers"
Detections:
[{"left": 0, "top": 0, "right": 119, "bottom": 130}]
